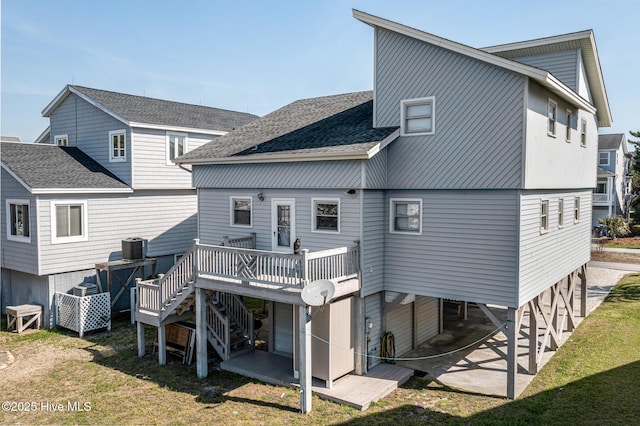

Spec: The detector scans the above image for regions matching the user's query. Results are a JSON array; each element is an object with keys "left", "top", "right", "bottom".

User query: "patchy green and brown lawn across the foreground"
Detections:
[{"left": 0, "top": 274, "right": 640, "bottom": 425}]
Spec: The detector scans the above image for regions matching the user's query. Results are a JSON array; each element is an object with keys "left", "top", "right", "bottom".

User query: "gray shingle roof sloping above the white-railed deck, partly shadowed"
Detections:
[{"left": 179, "top": 91, "right": 397, "bottom": 163}]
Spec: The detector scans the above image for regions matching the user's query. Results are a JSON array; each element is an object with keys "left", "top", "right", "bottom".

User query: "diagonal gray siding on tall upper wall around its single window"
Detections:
[{"left": 375, "top": 29, "right": 525, "bottom": 189}]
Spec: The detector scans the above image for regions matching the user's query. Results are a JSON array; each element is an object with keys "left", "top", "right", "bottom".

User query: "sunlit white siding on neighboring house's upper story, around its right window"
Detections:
[{"left": 132, "top": 128, "right": 215, "bottom": 189}]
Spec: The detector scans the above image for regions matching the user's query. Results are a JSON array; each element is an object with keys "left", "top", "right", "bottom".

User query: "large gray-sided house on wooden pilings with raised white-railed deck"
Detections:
[{"left": 131, "top": 11, "right": 611, "bottom": 411}]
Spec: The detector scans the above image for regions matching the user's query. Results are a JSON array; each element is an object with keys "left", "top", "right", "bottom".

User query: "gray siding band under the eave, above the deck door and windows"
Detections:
[{"left": 193, "top": 161, "right": 362, "bottom": 189}]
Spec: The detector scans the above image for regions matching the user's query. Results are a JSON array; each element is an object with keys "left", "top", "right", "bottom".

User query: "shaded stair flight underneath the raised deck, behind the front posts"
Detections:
[{"left": 207, "top": 292, "right": 255, "bottom": 361}]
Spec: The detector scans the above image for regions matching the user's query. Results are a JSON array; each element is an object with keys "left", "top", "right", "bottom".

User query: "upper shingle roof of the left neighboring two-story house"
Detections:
[{"left": 69, "top": 86, "right": 258, "bottom": 132}]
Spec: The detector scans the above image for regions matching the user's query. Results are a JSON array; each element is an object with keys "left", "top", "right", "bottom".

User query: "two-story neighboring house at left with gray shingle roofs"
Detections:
[{"left": 1, "top": 86, "right": 257, "bottom": 326}]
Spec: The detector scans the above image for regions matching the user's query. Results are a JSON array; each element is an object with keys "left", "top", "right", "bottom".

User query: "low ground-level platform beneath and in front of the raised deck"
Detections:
[{"left": 220, "top": 350, "right": 413, "bottom": 410}]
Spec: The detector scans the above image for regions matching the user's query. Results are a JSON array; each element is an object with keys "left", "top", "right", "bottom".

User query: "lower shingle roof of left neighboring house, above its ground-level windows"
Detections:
[{"left": 0, "top": 142, "right": 129, "bottom": 190}]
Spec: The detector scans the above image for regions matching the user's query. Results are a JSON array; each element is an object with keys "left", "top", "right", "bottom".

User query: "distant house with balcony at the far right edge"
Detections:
[{"left": 592, "top": 133, "right": 632, "bottom": 226}]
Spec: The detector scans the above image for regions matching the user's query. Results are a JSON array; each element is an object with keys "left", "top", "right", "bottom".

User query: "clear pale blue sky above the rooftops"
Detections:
[{"left": 0, "top": 0, "right": 640, "bottom": 142}]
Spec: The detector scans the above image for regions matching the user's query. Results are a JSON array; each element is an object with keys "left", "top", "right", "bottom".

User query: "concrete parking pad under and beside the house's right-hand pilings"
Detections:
[{"left": 397, "top": 268, "right": 629, "bottom": 397}]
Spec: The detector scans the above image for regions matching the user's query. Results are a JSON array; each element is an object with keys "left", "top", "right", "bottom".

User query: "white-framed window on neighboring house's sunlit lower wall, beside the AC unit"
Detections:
[{"left": 51, "top": 200, "right": 89, "bottom": 244}]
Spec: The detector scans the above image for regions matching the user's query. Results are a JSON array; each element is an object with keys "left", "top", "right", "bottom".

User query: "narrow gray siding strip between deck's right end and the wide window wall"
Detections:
[{"left": 361, "top": 190, "right": 389, "bottom": 296}]
